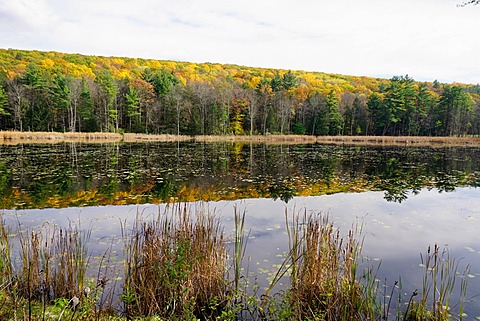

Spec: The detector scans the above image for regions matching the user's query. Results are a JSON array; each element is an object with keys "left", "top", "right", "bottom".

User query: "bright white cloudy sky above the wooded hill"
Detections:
[{"left": 0, "top": 0, "right": 480, "bottom": 84}]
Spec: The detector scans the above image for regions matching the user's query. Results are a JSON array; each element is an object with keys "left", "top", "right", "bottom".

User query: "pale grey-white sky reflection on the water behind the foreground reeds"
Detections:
[{"left": 3, "top": 188, "right": 480, "bottom": 315}]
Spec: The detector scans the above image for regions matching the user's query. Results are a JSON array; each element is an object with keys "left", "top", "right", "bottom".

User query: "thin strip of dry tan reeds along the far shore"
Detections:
[{"left": 0, "top": 131, "right": 480, "bottom": 147}]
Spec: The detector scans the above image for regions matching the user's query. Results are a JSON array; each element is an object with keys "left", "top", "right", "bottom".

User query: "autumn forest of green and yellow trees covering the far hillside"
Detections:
[{"left": 0, "top": 49, "right": 480, "bottom": 136}]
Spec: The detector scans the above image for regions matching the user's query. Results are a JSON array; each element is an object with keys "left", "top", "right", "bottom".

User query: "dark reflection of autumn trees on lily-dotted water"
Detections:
[{"left": 0, "top": 142, "right": 480, "bottom": 207}]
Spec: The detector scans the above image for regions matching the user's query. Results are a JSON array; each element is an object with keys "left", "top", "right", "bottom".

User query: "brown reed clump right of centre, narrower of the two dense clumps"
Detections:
[{"left": 289, "top": 213, "right": 374, "bottom": 320}]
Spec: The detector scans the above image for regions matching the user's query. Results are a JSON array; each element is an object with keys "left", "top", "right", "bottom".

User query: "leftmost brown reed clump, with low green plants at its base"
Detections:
[{"left": 0, "top": 220, "right": 111, "bottom": 320}]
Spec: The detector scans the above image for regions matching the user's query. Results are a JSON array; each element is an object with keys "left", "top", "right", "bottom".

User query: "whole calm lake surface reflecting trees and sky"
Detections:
[{"left": 0, "top": 142, "right": 480, "bottom": 319}]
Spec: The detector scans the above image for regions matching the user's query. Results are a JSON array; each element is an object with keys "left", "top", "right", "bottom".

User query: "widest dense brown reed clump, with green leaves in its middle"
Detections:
[{"left": 122, "top": 204, "right": 228, "bottom": 320}]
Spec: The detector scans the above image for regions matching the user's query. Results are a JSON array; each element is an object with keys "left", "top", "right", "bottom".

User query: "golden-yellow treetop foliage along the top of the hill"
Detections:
[{"left": 0, "top": 49, "right": 388, "bottom": 100}]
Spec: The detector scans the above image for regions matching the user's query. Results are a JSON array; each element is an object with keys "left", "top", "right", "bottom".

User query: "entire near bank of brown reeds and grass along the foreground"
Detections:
[{"left": 0, "top": 204, "right": 468, "bottom": 321}]
